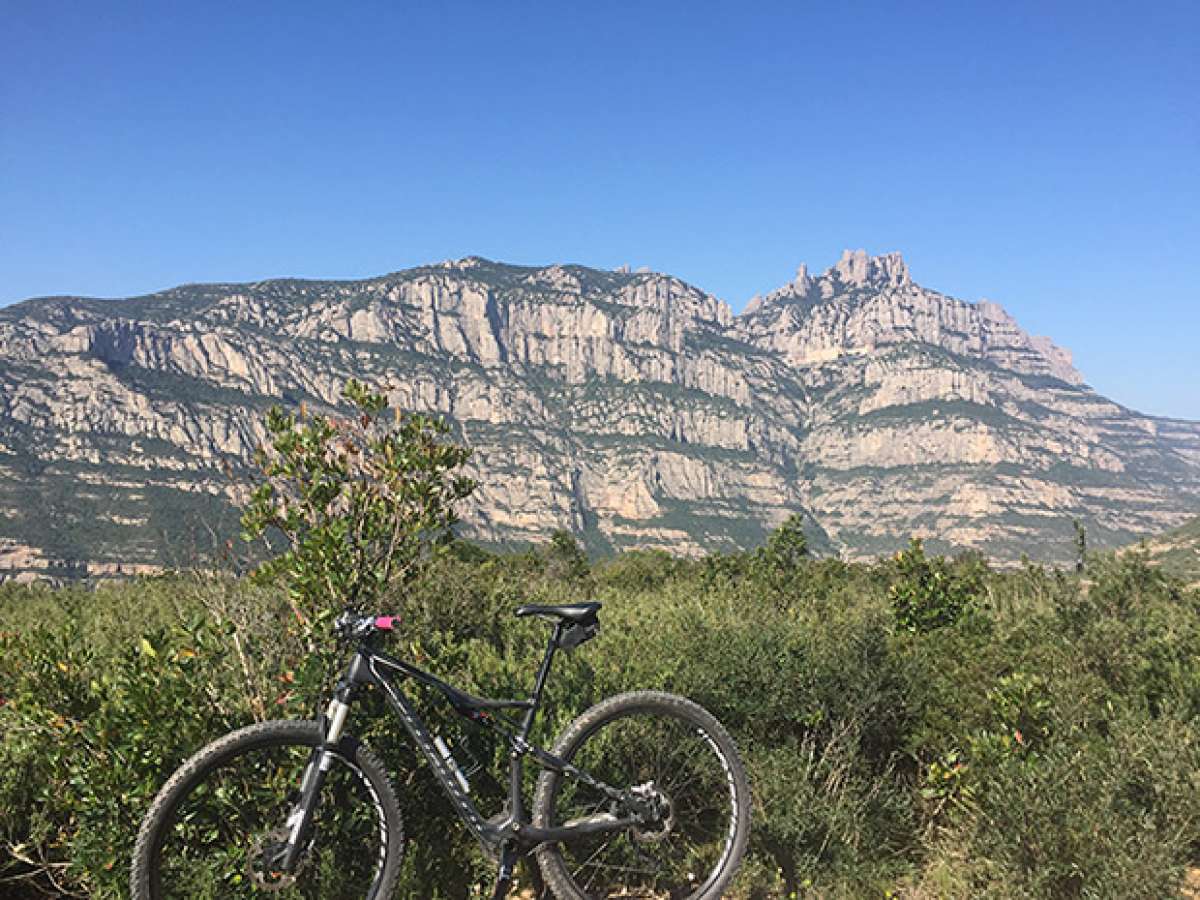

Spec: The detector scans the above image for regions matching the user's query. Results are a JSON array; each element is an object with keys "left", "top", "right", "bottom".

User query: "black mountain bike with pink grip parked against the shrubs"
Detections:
[{"left": 131, "top": 602, "right": 750, "bottom": 900}]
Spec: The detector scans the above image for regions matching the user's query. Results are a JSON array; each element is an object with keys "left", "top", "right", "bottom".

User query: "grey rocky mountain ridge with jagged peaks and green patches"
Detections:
[{"left": 0, "top": 251, "right": 1200, "bottom": 575}]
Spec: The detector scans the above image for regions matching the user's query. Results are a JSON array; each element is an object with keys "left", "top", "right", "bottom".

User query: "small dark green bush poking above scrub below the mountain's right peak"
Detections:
[{"left": 890, "top": 538, "right": 982, "bottom": 634}]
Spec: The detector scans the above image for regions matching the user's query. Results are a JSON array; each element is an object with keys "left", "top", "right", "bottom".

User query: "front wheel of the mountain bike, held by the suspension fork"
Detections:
[{"left": 132, "top": 721, "right": 403, "bottom": 900}]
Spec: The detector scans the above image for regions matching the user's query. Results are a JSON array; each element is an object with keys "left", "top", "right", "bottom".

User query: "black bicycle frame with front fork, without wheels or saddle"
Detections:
[{"left": 283, "top": 623, "right": 653, "bottom": 871}]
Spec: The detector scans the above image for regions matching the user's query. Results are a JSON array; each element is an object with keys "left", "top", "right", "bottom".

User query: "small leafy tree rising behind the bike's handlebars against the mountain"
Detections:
[{"left": 241, "top": 379, "right": 475, "bottom": 622}]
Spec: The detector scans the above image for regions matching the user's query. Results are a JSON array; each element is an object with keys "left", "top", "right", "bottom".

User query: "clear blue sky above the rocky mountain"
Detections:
[{"left": 0, "top": 0, "right": 1200, "bottom": 419}]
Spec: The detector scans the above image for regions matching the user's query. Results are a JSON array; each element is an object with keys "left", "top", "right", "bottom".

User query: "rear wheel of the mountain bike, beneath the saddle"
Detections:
[{"left": 534, "top": 691, "right": 750, "bottom": 900}]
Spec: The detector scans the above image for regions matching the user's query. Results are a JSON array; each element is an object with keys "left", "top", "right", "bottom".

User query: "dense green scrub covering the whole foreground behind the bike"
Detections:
[{"left": 0, "top": 547, "right": 1200, "bottom": 900}]
